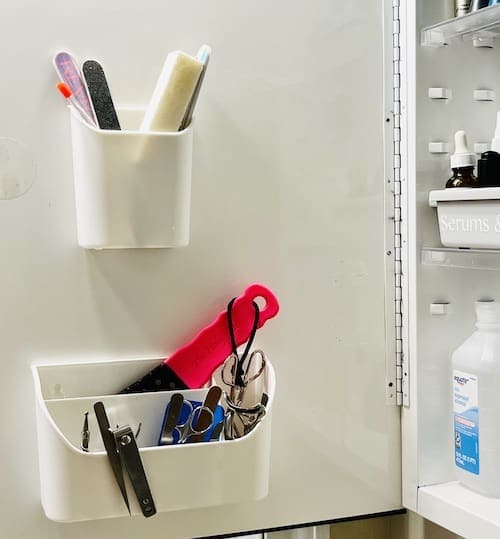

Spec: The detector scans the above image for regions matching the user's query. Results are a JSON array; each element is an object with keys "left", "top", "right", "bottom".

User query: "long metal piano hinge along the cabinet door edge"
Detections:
[{"left": 392, "top": 0, "right": 408, "bottom": 406}]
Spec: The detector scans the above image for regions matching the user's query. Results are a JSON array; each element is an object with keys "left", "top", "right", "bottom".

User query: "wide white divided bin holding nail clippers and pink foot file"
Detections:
[{"left": 33, "top": 359, "right": 275, "bottom": 522}]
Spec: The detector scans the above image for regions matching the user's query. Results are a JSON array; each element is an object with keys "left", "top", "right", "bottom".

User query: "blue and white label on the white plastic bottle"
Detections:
[{"left": 453, "top": 371, "right": 479, "bottom": 475}]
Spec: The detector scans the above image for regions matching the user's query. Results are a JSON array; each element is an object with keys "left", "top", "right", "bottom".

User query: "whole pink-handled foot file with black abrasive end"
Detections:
[{"left": 120, "top": 284, "right": 279, "bottom": 393}]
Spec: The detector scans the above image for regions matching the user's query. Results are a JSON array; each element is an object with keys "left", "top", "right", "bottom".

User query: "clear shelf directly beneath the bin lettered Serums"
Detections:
[{"left": 421, "top": 247, "right": 500, "bottom": 270}]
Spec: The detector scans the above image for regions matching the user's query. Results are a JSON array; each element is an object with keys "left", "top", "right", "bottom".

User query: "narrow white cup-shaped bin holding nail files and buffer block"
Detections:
[{"left": 70, "top": 107, "right": 193, "bottom": 249}]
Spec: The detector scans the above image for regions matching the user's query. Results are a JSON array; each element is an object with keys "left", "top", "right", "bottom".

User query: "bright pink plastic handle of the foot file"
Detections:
[{"left": 164, "top": 284, "right": 279, "bottom": 389}]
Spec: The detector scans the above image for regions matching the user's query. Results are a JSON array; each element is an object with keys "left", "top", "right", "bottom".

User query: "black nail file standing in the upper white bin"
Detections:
[{"left": 82, "top": 60, "right": 120, "bottom": 130}]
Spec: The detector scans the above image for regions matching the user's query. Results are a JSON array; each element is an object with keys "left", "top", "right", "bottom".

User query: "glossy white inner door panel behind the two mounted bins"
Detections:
[{"left": 0, "top": 0, "right": 401, "bottom": 539}]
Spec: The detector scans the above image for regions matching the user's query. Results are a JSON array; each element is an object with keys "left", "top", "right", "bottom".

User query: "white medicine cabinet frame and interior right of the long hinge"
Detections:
[{"left": 399, "top": 0, "right": 500, "bottom": 539}]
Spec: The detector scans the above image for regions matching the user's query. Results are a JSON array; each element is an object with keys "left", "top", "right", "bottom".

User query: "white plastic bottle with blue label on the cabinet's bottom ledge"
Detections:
[{"left": 452, "top": 301, "right": 500, "bottom": 497}]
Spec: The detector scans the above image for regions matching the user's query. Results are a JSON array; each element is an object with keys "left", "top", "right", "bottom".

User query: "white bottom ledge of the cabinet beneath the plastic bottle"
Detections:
[{"left": 418, "top": 482, "right": 500, "bottom": 539}]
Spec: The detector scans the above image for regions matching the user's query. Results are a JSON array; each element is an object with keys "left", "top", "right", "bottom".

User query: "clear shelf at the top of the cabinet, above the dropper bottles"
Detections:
[{"left": 421, "top": 4, "right": 500, "bottom": 47}]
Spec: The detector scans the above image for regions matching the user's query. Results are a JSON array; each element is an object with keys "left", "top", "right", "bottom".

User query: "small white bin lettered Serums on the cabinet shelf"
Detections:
[{"left": 429, "top": 187, "right": 500, "bottom": 249}]
